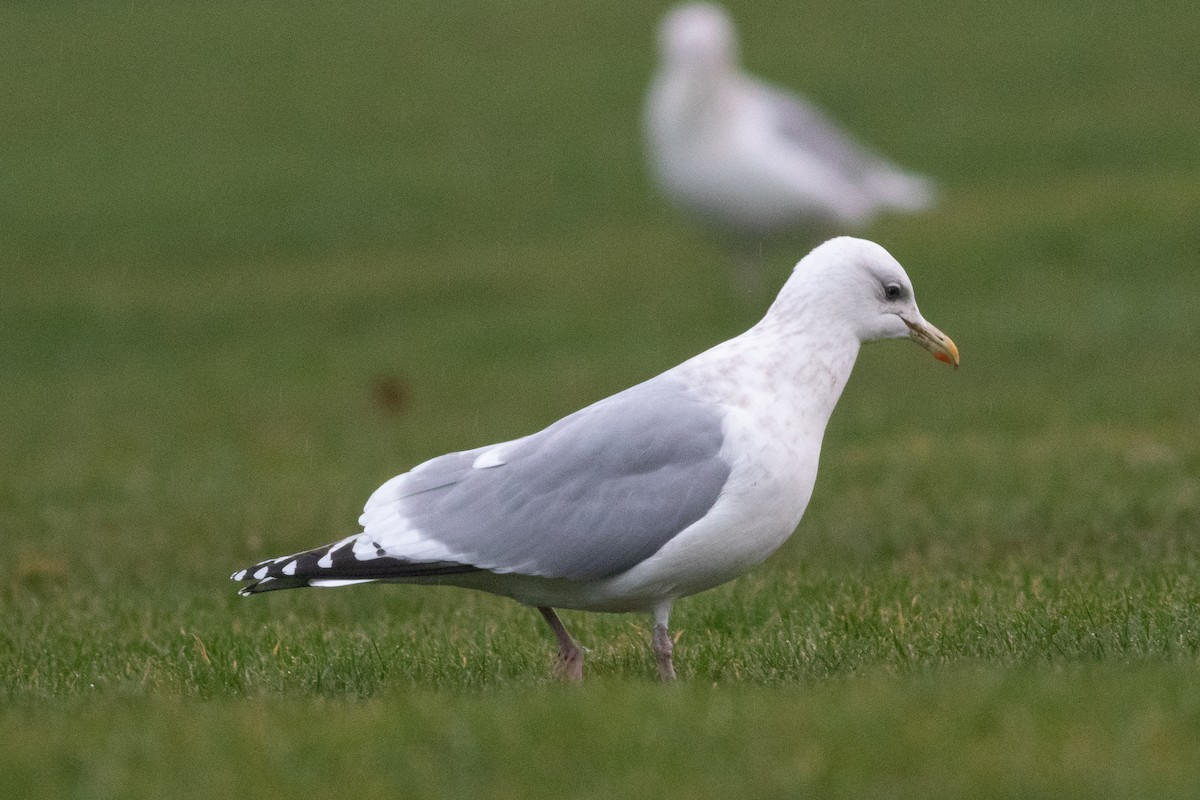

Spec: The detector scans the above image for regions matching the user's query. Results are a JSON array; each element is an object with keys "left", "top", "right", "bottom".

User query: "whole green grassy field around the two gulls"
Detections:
[{"left": 0, "top": 0, "right": 1200, "bottom": 799}]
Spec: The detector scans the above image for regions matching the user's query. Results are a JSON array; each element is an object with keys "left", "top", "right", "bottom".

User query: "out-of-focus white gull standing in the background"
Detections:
[{"left": 644, "top": 4, "right": 934, "bottom": 255}]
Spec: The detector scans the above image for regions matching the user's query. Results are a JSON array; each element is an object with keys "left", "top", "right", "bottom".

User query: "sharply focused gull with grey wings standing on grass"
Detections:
[{"left": 232, "top": 236, "right": 959, "bottom": 681}]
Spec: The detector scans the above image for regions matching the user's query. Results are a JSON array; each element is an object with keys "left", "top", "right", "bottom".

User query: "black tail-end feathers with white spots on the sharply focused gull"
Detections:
[{"left": 229, "top": 534, "right": 479, "bottom": 596}]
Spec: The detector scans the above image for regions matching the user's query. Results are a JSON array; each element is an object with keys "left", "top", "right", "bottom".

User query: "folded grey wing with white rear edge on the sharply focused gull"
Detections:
[{"left": 353, "top": 378, "right": 730, "bottom": 579}]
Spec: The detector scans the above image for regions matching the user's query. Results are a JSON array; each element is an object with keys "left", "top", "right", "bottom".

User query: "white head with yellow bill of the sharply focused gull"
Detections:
[{"left": 763, "top": 236, "right": 959, "bottom": 369}]
